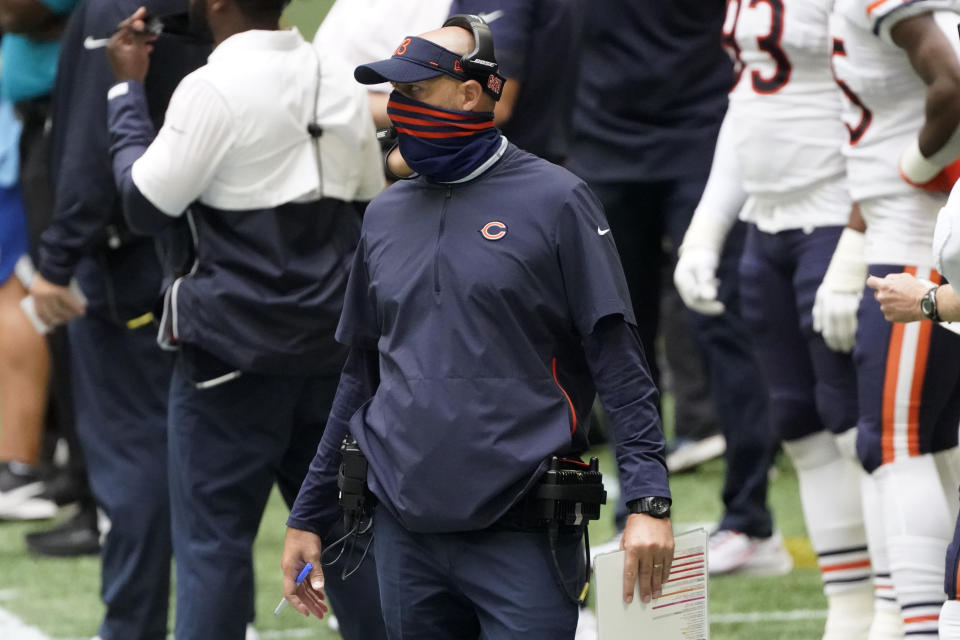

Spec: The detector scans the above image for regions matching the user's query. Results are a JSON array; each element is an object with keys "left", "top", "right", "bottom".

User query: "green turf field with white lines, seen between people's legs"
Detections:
[{"left": 0, "top": 451, "right": 825, "bottom": 640}]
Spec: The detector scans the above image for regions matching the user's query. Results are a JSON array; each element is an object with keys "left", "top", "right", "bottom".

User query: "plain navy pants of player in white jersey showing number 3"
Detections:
[{"left": 740, "top": 226, "right": 857, "bottom": 440}]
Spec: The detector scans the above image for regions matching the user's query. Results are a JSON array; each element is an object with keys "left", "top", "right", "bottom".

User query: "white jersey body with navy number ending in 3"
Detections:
[{"left": 724, "top": 0, "right": 850, "bottom": 233}]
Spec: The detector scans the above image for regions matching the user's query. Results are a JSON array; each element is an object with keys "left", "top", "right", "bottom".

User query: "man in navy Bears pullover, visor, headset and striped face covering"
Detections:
[{"left": 283, "top": 16, "right": 673, "bottom": 640}]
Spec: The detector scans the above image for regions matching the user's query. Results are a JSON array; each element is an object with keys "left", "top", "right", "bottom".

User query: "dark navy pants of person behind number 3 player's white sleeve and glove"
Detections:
[{"left": 590, "top": 174, "right": 776, "bottom": 537}]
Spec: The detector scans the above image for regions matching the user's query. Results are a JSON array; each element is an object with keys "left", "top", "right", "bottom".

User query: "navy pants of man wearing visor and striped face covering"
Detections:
[{"left": 373, "top": 505, "right": 583, "bottom": 640}]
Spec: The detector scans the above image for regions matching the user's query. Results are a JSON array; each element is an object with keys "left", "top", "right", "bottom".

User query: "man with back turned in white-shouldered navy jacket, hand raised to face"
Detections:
[{"left": 108, "top": 0, "right": 385, "bottom": 640}]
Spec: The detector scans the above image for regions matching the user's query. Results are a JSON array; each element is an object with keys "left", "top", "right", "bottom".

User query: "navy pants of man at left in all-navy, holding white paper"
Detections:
[{"left": 67, "top": 310, "right": 173, "bottom": 640}]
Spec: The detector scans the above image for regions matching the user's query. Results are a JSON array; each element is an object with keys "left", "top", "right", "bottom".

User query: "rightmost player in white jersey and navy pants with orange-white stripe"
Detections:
[{"left": 818, "top": 0, "right": 960, "bottom": 638}]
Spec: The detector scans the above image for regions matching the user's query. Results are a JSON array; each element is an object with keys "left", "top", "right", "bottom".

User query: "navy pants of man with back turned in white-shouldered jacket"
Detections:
[{"left": 169, "top": 346, "right": 386, "bottom": 640}]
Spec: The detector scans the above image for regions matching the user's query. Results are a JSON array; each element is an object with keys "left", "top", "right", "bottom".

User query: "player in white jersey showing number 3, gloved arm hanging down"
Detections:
[{"left": 674, "top": 0, "right": 874, "bottom": 640}]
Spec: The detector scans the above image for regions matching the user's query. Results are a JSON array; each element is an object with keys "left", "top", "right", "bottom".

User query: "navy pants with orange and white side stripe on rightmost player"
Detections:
[{"left": 853, "top": 264, "right": 960, "bottom": 473}]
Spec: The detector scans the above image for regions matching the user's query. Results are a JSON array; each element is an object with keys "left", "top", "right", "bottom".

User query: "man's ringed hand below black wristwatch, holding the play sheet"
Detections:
[{"left": 620, "top": 513, "right": 673, "bottom": 602}]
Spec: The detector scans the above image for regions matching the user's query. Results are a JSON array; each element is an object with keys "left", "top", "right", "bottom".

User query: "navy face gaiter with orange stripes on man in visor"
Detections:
[{"left": 387, "top": 91, "right": 500, "bottom": 182}]
